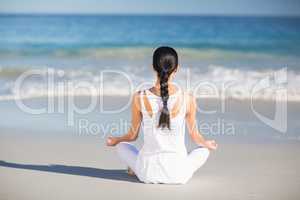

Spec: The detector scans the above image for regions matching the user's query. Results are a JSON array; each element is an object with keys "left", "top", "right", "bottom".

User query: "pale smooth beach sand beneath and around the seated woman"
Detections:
[{"left": 0, "top": 96, "right": 300, "bottom": 200}]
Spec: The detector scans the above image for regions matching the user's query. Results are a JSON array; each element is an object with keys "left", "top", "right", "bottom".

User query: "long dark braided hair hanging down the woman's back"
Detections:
[{"left": 153, "top": 47, "right": 178, "bottom": 129}]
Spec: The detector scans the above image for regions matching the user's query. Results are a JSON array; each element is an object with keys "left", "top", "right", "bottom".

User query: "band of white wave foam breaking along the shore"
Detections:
[{"left": 0, "top": 65, "right": 300, "bottom": 101}]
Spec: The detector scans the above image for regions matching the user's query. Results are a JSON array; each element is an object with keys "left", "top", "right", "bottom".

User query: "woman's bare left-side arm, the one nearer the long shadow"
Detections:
[{"left": 106, "top": 92, "right": 142, "bottom": 146}]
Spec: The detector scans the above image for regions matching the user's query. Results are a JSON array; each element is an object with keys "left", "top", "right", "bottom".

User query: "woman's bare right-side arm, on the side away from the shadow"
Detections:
[{"left": 186, "top": 94, "right": 217, "bottom": 150}]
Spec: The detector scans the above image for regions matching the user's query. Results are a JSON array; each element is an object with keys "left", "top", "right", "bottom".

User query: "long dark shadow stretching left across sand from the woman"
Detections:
[{"left": 0, "top": 160, "right": 139, "bottom": 183}]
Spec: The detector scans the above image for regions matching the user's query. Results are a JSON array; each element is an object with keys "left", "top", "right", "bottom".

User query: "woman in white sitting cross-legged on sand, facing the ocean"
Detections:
[{"left": 107, "top": 47, "right": 217, "bottom": 184}]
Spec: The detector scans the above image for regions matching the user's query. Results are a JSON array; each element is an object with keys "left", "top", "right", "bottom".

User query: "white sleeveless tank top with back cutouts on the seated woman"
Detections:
[{"left": 135, "top": 90, "right": 192, "bottom": 184}]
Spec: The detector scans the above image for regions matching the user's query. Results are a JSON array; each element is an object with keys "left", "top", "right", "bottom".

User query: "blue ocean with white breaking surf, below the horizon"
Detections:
[{"left": 0, "top": 15, "right": 300, "bottom": 101}]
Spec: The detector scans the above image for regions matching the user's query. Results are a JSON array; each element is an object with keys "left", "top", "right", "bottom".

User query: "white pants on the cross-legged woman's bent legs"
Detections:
[{"left": 117, "top": 142, "right": 209, "bottom": 176}]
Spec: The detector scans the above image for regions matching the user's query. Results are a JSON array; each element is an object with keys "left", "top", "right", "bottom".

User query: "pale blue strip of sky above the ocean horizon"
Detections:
[{"left": 0, "top": 0, "right": 300, "bottom": 16}]
